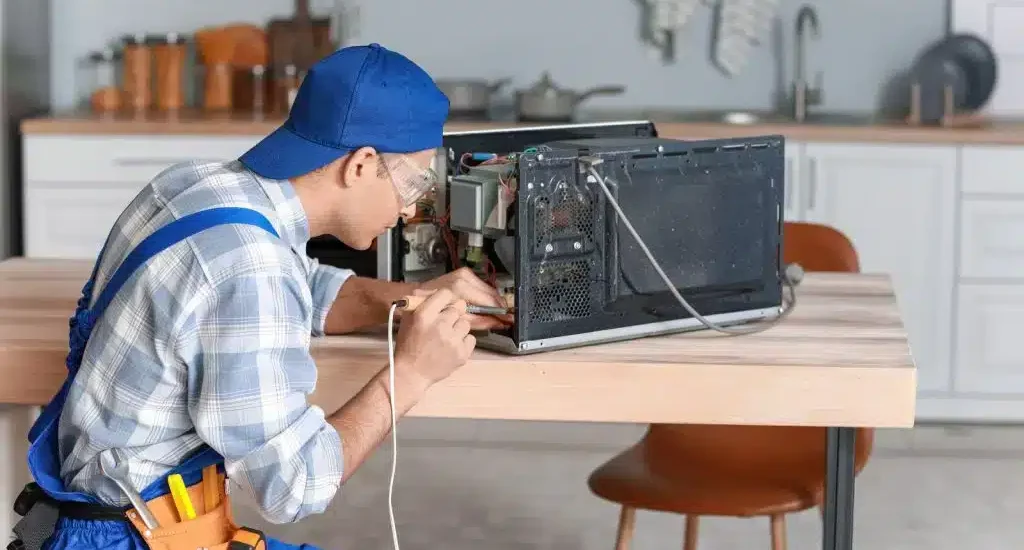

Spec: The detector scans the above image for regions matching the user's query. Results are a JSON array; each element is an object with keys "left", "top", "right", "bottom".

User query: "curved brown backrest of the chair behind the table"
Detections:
[{"left": 640, "top": 222, "right": 874, "bottom": 481}]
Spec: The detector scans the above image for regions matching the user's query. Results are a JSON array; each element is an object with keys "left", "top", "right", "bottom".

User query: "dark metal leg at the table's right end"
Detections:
[{"left": 822, "top": 428, "right": 857, "bottom": 550}]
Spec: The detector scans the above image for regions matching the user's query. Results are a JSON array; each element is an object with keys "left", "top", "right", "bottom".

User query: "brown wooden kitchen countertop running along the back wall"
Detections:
[{"left": 14, "top": 107, "right": 1024, "bottom": 145}]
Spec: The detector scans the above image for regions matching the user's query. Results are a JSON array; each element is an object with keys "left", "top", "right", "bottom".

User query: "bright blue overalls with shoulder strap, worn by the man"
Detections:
[{"left": 29, "top": 207, "right": 316, "bottom": 550}]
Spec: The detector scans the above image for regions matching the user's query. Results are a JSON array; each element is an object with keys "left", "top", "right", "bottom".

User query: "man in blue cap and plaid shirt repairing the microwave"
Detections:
[{"left": 23, "top": 44, "right": 503, "bottom": 550}]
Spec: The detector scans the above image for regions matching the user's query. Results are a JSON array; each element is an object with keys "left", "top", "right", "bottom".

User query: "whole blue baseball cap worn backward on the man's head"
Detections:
[{"left": 240, "top": 44, "right": 449, "bottom": 179}]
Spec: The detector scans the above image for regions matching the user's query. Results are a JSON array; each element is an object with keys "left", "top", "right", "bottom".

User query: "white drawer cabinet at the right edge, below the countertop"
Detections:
[{"left": 923, "top": 145, "right": 1024, "bottom": 422}]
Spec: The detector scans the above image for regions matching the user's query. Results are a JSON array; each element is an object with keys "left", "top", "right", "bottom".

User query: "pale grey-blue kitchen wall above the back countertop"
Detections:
[{"left": 51, "top": 0, "right": 948, "bottom": 112}]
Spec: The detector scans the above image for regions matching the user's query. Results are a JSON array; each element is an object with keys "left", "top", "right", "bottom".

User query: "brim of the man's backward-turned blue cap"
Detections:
[{"left": 239, "top": 126, "right": 352, "bottom": 179}]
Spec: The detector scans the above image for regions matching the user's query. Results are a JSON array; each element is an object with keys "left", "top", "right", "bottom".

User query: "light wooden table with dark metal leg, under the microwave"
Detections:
[{"left": 0, "top": 259, "right": 916, "bottom": 550}]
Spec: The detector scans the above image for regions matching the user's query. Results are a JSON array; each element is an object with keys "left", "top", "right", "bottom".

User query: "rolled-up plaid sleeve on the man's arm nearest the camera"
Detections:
[{"left": 178, "top": 268, "right": 343, "bottom": 523}]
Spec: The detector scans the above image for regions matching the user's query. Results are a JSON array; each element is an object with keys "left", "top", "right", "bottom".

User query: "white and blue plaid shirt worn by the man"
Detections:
[{"left": 59, "top": 162, "right": 352, "bottom": 522}]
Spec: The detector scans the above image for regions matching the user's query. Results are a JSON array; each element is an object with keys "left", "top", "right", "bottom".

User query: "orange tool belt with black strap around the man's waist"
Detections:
[{"left": 7, "top": 466, "right": 266, "bottom": 550}]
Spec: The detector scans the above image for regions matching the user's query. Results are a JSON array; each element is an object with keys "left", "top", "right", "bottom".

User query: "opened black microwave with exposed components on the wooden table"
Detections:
[{"left": 303, "top": 121, "right": 785, "bottom": 354}]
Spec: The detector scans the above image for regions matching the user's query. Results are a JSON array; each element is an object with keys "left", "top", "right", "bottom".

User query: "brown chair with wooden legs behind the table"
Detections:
[{"left": 589, "top": 222, "right": 874, "bottom": 550}]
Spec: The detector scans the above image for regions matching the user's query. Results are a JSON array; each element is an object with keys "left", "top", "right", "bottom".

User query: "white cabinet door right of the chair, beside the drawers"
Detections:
[{"left": 802, "top": 143, "right": 956, "bottom": 392}]
